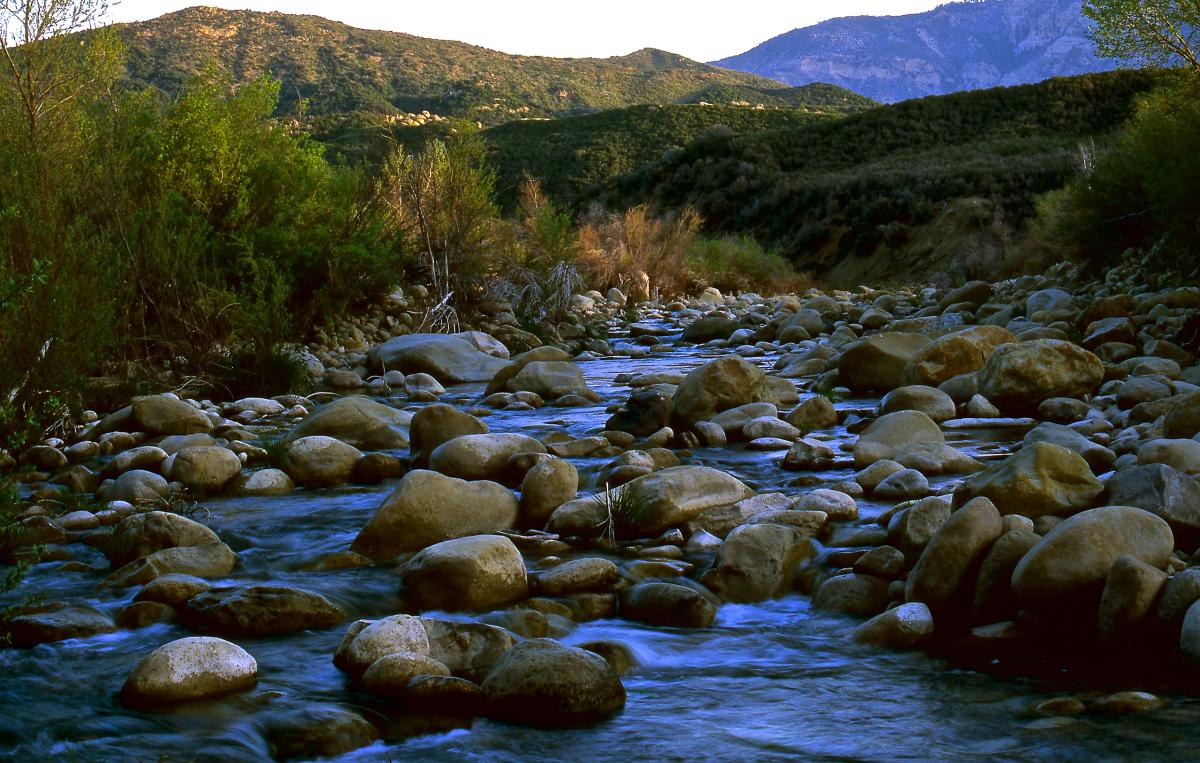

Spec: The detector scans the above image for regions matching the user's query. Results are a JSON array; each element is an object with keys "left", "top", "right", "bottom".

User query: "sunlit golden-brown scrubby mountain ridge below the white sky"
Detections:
[{"left": 115, "top": 7, "right": 869, "bottom": 124}]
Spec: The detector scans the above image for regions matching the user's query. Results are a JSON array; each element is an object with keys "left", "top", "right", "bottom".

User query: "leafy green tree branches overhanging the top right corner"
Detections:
[{"left": 1084, "top": 0, "right": 1200, "bottom": 73}]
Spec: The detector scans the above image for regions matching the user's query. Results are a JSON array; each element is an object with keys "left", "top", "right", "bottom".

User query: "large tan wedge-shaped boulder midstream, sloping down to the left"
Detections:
[{"left": 350, "top": 469, "right": 518, "bottom": 560}]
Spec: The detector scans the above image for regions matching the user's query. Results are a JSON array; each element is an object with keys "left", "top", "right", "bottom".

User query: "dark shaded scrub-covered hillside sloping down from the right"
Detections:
[{"left": 605, "top": 71, "right": 1160, "bottom": 283}]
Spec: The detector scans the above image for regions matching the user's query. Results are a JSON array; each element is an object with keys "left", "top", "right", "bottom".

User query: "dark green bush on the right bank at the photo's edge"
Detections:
[{"left": 1040, "top": 76, "right": 1200, "bottom": 266}]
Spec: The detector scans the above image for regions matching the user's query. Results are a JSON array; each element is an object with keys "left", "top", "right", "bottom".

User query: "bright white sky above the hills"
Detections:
[{"left": 109, "top": 0, "right": 946, "bottom": 61}]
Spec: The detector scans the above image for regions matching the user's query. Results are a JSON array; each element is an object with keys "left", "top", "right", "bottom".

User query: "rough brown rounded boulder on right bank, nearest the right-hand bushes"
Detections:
[{"left": 979, "top": 340, "right": 1104, "bottom": 414}]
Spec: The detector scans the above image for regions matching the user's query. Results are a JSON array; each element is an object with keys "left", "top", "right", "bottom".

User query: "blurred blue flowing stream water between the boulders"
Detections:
[{"left": 0, "top": 331, "right": 1200, "bottom": 763}]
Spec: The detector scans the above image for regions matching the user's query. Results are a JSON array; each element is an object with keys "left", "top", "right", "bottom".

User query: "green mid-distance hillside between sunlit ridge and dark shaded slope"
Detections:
[{"left": 484, "top": 106, "right": 862, "bottom": 209}]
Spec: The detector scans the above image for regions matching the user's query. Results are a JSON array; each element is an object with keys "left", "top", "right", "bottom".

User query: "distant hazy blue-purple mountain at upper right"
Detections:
[{"left": 715, "top": 0, "right": 1115, "bottom": 103}]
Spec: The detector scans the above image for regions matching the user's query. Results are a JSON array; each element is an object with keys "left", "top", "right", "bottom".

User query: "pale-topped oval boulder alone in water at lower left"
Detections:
[{"left": 121, "top": 637, "right": 258, "bottom": 708}]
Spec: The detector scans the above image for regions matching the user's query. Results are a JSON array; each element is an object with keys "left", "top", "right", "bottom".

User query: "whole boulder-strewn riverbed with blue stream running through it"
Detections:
[{"left": 0, "top": 260, "right": 1200, "bottom": 761}]
